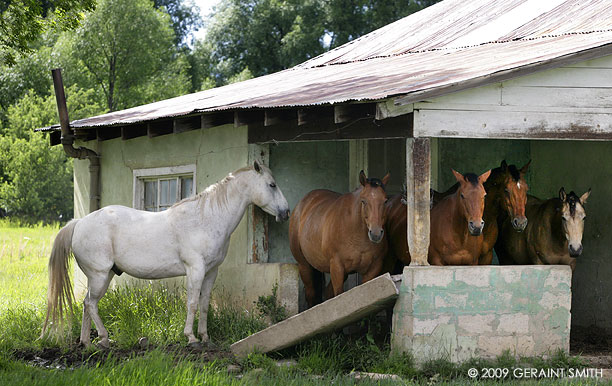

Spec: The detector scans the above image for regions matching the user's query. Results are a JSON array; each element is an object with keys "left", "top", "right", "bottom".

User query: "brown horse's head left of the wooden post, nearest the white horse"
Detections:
[{"left": 359, "top": 170, "right": 389, "bottom": 243}]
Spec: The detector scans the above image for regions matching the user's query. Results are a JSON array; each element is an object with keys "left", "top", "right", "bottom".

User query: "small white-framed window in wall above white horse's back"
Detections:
[{"left": 133, "top": 165, "right": 195, "bottom": 212}]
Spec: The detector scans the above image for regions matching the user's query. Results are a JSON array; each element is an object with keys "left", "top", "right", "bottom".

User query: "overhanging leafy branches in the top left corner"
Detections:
[{"left": 0, "top": 0, "right": 96, "bottom": 65}]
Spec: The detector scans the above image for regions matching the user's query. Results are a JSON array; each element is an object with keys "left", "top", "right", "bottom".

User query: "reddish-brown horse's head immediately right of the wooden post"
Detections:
[{"left": 453, "top": 169, "right": 491, "bottom": 236}]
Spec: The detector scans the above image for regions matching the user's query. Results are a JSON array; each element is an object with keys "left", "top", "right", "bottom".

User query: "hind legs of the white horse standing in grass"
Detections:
[{"left": 81, "top": 271, "right": 115, "bottom": 348}]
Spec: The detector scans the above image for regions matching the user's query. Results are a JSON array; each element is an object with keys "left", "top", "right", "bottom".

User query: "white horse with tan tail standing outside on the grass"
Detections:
[{"left": 41, "top": 161, "right": 289, "bottom": 347}]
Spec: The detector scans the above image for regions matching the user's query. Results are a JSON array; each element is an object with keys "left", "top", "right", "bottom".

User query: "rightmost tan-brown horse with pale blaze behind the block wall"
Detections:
[{"left": 495, "top": 188, "right": 591, "bottom": 270}]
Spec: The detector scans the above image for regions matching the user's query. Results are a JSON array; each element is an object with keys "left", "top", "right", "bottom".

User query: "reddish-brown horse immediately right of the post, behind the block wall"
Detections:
[{"left": 428, "top": 170, "right": 491, "bottom": 265}]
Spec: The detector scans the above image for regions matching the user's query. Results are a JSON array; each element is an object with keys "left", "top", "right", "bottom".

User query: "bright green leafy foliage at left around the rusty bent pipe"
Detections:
[{"left": 0, "top": 86, "right": 103, "bottom": 221}]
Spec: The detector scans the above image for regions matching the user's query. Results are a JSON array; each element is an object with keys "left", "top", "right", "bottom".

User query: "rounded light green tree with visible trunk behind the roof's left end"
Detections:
[{"left": 65, "top": 0, "right": 189, "bottom": 111}]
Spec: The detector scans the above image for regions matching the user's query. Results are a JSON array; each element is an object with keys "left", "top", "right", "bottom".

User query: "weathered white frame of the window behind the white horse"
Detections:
[{"left": 132, "top": 164, "right": 197, "bottom": 210}]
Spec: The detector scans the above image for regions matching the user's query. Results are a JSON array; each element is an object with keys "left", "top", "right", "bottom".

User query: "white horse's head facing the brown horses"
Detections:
[{"left": 251, "top": 161, "right": 289, "bottom": 222}]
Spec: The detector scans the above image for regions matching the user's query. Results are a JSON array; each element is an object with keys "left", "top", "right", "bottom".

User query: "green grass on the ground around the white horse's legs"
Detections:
[{"left": 0, "top": 221, "right": 594, "bottom": 385}]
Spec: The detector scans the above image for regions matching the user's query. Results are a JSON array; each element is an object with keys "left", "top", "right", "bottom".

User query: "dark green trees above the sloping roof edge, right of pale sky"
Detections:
[{"left": 194, "top": 0, "right": 439, "bottom": 85}]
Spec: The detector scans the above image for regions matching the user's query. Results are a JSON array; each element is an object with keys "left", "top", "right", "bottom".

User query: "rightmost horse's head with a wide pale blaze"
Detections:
[{"left": 559, "top": 188, "right": 591, "bottom": 257}]
